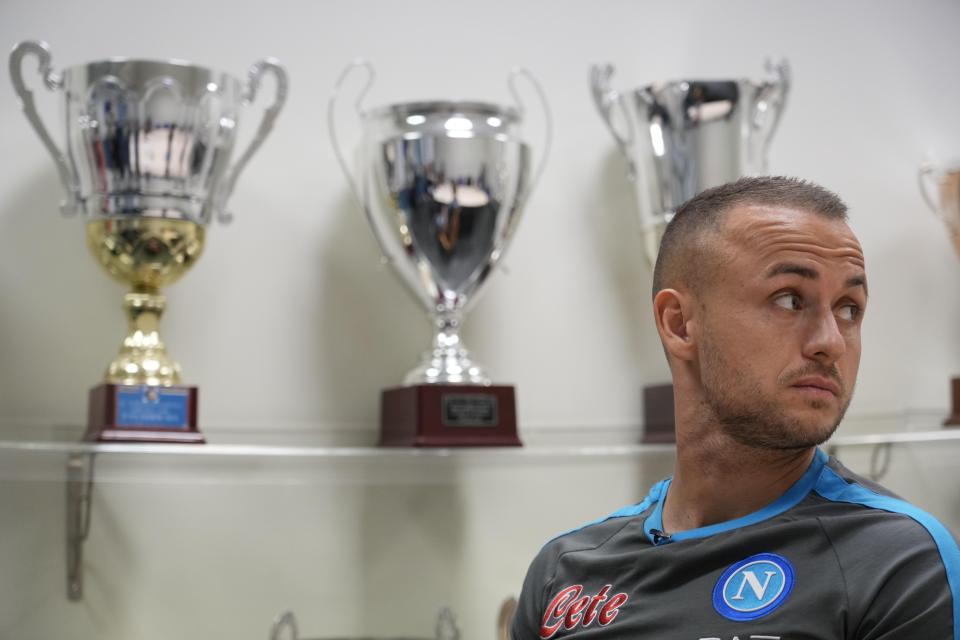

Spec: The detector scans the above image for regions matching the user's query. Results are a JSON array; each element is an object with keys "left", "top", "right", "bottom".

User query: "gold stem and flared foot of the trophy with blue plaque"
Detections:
[{"left": 104, "top": 287, "right": 180, "bottom": 387}]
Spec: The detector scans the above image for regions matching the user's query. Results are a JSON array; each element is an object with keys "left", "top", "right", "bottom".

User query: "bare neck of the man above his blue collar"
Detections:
[{"left": 663, "top": 430, "right": 816, "bottom": 533}]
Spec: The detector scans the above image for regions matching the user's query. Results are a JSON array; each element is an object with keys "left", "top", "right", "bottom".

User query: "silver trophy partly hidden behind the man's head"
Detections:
[{"left": 590, "top": 60, "right": 790, "bottom": 442}]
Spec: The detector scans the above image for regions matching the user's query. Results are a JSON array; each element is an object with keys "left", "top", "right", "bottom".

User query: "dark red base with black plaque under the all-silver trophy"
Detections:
[{"left": 380, "top": 384, "right": 522, "bottom": 447}]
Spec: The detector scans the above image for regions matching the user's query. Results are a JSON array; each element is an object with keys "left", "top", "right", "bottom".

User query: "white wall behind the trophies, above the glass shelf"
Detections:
[{"left": 0, "top": 0, "right": 960, "bottom": 438}]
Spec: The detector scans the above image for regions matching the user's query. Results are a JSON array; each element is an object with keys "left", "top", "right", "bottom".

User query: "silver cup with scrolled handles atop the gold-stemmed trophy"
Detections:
[{"left": 10, "top": 41, "right": 287, "bottom": 225}]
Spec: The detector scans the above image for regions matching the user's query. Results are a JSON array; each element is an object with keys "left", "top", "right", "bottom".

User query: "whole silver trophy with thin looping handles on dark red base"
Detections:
[{"left": 328, "top": 60, "right": 551, "bottom": 447}]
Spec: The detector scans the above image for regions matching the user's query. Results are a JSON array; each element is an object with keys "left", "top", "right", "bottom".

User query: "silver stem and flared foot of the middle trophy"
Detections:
[{"left": 404, "top": 312, "right": 490, "bottom": 385}]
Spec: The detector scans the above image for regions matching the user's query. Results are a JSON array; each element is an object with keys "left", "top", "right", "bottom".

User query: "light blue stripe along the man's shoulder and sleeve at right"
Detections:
[{"left": 815, "top": 467, "right": 960, "bottom": 640}]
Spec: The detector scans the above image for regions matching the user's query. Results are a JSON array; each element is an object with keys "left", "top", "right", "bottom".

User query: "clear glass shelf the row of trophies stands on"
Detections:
[{"left": 0, "top": 429, "right": 960, "bottom": 484}]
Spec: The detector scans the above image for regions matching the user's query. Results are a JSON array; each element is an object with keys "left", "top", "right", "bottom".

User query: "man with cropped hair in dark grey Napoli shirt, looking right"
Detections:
[{"left": 512, "top": 177, "right": 960, "bottom": 640}]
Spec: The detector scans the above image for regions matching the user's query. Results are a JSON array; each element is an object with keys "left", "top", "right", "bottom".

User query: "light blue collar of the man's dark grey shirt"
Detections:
[{"left": 643, "top": 448, "right": 827, "bottom": 544}]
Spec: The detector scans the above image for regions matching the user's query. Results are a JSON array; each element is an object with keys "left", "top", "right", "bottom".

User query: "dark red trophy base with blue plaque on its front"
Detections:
[{"left": 84, "top": 383, "right": 206, "bottom": 444}]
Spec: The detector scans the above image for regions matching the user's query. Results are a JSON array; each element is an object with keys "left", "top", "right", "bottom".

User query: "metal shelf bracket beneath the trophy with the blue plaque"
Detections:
[{"left": 67, "top": 453, "right": 94, "bottom": 602}]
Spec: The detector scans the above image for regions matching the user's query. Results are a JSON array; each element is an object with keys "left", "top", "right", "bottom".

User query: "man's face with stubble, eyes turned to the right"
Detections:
[{"left": 697, "top": 206, "right": 867, "bottom": 449}]
